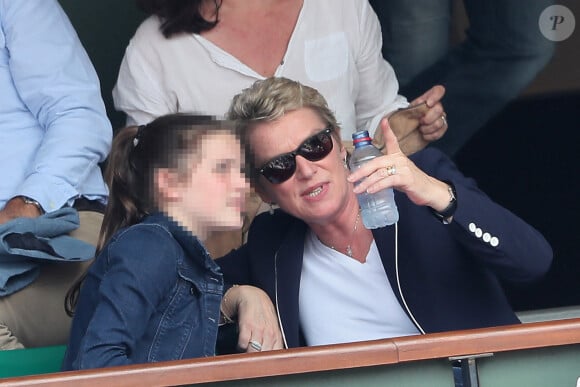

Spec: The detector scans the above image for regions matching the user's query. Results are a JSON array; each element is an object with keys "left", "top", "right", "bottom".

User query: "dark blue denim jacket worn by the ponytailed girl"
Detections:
[{"left": 63, "top": 213, "right": 223, "bottom": 370}]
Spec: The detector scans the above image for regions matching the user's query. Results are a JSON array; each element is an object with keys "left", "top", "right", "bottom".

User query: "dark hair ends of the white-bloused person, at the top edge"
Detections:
[{"left": 137, "top": 0, "right": 221, "bottom": 38}]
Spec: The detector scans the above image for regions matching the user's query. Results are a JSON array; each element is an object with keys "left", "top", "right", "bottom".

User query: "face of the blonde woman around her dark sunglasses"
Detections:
[{"left": 249, "top": 108, "right": 352, "bottom": 223}]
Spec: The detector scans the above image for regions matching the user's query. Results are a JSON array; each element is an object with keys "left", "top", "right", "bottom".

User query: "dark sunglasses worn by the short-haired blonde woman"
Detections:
[{"left": 258, "top": 127, "right": 333, "bottom": 184}]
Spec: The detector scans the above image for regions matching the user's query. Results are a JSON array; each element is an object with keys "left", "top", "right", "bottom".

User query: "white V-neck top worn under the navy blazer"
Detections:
[{"left": 299, "top": 232, "right": 419, "bottom": 346}]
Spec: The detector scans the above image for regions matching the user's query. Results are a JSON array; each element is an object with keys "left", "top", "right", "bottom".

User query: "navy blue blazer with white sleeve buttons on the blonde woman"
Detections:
[{"left": 217, "top": 148, "right": 552, "bottom": 347}]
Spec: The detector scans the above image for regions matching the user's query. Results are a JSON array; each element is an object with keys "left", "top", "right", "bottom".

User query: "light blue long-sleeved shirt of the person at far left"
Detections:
[{"left": 0, "top": 0, "right": 112, "bottom": 212}]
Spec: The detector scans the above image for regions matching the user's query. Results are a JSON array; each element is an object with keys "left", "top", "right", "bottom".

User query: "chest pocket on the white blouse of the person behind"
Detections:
[{"left": 304, "top": 32, "right": 348, "bottom": 82}]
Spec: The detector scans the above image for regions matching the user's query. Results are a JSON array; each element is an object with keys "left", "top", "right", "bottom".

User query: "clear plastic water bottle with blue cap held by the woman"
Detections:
[{"left": 349, "top": 130, "right": 399, "bottom": 229}]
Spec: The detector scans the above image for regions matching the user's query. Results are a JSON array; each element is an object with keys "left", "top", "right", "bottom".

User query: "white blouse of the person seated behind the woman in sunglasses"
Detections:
[{"left": 113, "top": 0, "right": 408, "bottom": 140}]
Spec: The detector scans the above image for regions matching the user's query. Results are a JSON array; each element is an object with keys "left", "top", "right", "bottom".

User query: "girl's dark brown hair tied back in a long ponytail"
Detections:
[{"left": 65, "top": 114, "right": 239, "bottom": 316}]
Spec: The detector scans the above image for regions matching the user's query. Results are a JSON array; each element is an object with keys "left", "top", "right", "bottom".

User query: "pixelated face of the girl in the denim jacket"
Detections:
[{"left": 171, "top": 132, "right": 249, "bottom": 239}]
